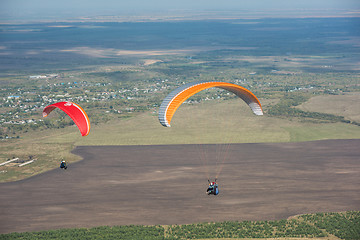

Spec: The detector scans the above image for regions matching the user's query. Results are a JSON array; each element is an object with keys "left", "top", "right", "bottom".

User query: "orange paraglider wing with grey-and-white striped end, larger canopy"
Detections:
[{"left": 159, "top": 81, "right": 263, "bottom": 127}]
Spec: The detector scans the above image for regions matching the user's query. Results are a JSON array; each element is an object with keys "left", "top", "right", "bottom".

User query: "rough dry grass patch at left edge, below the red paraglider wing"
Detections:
[{"left": 0, "top": 127, "right": 81, "bottom": 182}]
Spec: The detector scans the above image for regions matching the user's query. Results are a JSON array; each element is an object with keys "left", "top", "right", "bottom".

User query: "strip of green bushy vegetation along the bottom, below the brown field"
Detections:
[{"left": 0, "top": 211, "right": 360, "bottom": 240}]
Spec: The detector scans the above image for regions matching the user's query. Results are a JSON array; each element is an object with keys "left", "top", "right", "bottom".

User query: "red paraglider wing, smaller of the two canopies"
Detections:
[{"left": 43, "top": 102, "right": 90, "bottom": 136}]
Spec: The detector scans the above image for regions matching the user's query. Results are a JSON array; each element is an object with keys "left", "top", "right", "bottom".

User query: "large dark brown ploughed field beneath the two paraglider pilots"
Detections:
[{"left": 0, "top": 139, "right": 360, "bottom": 233}]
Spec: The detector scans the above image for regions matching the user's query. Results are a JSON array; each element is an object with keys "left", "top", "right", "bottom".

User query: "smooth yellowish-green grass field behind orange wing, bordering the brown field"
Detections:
[{"left": 76, "top": 99, "right": 360, "bottom": 145}]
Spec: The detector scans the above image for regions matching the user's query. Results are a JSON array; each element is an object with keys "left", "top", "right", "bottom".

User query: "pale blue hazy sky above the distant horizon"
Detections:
[{"left": 0, "top": 0, "right": 360, "bottom": 20}]
